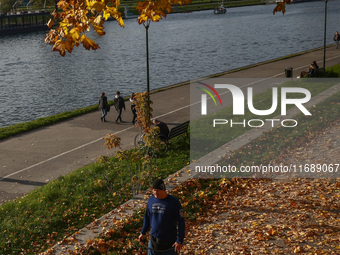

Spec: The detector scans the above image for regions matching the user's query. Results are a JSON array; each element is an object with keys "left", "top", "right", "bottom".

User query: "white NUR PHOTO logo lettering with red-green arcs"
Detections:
[{"left": 197, "top": 82, "right": 312, "bottom": 127}]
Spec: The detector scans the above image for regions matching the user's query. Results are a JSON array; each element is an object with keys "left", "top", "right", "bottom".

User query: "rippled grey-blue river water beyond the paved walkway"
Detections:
[{"left": 0, "top": 0, "right": 340, "bottom": 127}]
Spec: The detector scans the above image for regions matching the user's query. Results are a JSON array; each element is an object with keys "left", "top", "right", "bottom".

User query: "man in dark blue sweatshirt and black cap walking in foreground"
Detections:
[{"left": 139, "top": 179, "right": 185, "bottom": 255}]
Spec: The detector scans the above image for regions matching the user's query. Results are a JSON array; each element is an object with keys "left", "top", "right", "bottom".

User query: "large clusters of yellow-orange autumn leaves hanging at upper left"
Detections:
[{"left": 45, "top": 0, "right": 191, "bottom": 56}]
